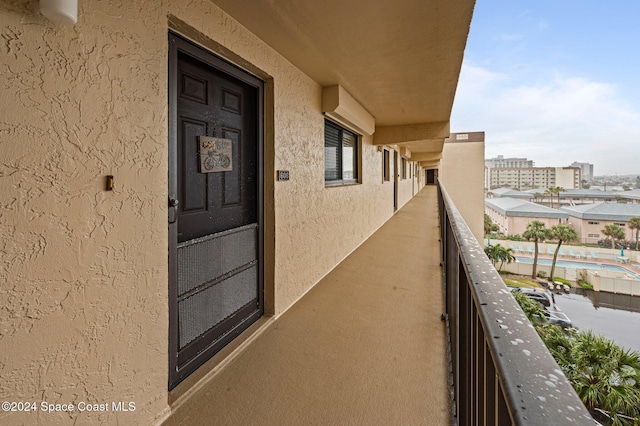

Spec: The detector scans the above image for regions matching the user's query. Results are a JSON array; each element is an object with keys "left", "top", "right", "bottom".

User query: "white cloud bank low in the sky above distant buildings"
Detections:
[{"left": 451, "top": 62, "right": 640, "bottom": 175}]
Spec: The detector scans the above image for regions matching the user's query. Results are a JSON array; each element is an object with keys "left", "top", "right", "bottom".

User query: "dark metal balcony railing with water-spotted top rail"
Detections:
[{"left": 438, "top": 184, "right": 598, "bottom": 426}]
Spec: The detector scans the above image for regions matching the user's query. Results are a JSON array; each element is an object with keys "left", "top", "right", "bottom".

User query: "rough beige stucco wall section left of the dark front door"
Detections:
[{"left": 0, "top": 1, "right": 167, "bottom": 425}]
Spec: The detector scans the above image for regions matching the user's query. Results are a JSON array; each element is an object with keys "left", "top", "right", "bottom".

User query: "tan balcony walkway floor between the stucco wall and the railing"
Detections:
[{"left": 164, "top": 186, "right": 450, "bottom": 425}]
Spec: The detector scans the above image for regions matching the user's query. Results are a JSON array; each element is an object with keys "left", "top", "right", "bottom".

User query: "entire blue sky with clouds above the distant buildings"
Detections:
[{"left": 451, "top": 0, "right": 640, "bottom": 175}]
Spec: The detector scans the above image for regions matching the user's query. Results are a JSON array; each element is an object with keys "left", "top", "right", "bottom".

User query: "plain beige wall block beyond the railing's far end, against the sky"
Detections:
[{"left": 438, "top": 142, "right": 484, "bottom": 243}]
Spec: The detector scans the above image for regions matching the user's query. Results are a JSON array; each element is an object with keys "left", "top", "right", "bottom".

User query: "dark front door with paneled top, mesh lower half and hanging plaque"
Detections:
[{"left": 168, "top": 35, "right": 263, "bottom": 388}]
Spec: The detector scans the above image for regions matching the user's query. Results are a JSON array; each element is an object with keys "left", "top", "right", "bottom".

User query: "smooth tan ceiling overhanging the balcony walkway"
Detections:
[{"left": 212, "top": 0, "right": 475, "bottom": 126}]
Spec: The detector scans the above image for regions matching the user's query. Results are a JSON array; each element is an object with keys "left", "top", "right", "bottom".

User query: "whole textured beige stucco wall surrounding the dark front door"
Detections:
[{"left": 0, "top": 0, "right": 400, "bottom": 424}]
